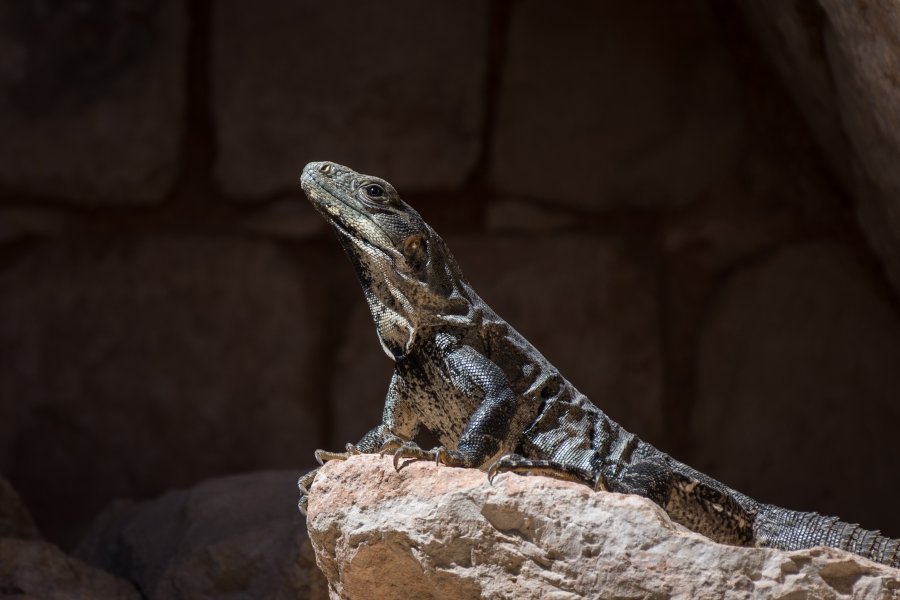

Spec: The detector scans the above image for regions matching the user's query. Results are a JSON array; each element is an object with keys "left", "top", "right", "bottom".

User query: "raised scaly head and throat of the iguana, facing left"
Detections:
[{"left": 300, "top": 162, "right": 471, "bottom": 359}]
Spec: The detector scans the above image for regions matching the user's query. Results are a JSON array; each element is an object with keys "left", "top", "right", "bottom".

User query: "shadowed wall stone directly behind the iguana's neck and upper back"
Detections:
[{"left": 329, "top": 235, "right": 665, "bottom": 448}]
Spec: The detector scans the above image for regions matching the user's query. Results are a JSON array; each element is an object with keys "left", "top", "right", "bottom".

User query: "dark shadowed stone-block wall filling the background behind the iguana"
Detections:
[{"left": 0, "top": 0, "right": 900, "bottom": 546}]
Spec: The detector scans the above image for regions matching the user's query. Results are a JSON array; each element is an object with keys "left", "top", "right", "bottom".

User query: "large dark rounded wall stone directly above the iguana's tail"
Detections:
[{"left": 700, "top": 244, "right": 900, "bottom": 537}]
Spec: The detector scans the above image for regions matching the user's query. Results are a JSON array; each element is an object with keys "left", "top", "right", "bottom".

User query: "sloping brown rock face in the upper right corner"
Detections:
[{"left": 740, "top": 0, "right": 900, "bottom": 289}]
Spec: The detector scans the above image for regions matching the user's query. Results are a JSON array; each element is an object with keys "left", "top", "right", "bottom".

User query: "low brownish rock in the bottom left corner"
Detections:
[{"left": 0, "top": 538, "right": 141, "bottom": 600}]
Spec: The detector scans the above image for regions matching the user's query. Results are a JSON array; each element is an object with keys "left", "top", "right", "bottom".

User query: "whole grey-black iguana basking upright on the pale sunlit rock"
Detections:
[{"left": 299, "top": 162, "right": 900, "bottom": 567}]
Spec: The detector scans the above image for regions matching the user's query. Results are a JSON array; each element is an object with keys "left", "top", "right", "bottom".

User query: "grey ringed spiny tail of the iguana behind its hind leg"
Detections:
[{"left": 753, "top": 504, "right": 900, "bottom": 568}]
